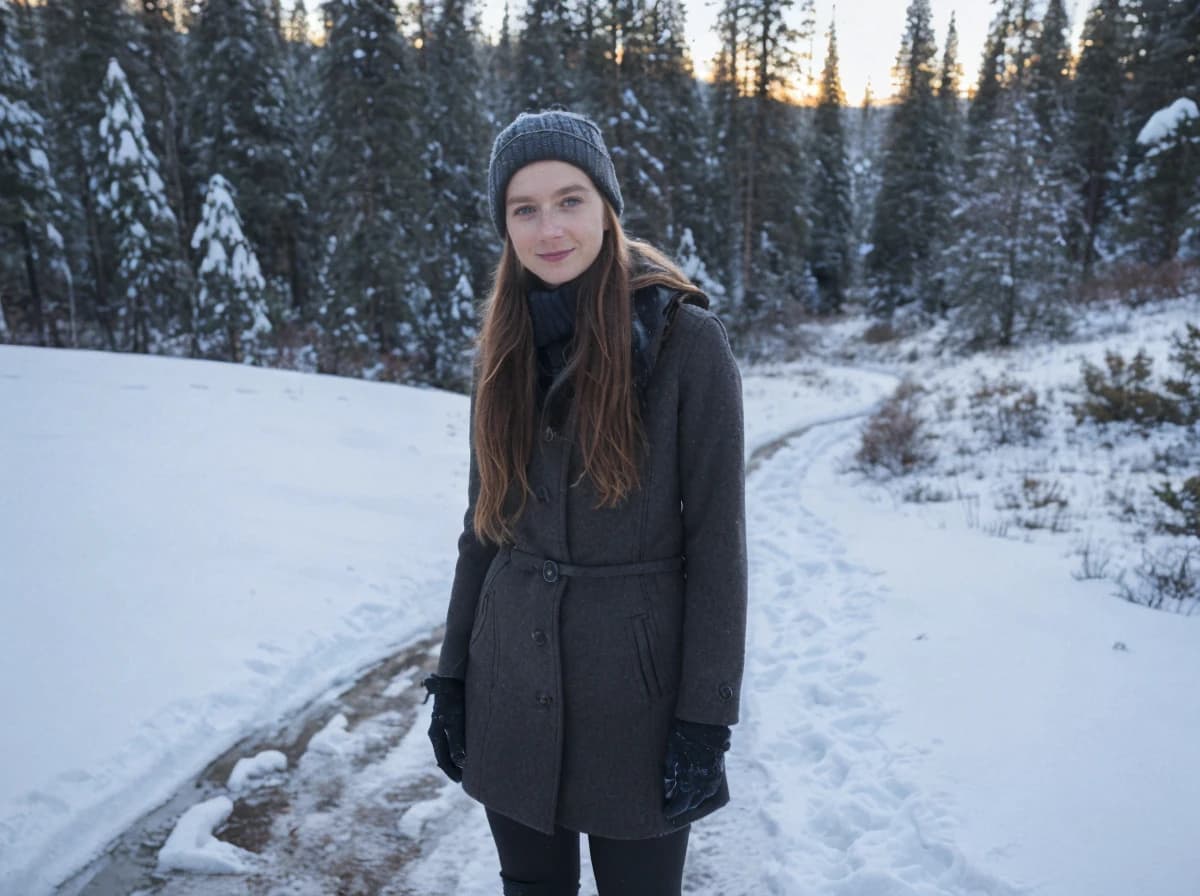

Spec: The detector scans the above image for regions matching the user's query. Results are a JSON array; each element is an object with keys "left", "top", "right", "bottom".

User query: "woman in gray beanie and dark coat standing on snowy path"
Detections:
[{"left": 425, "top": 112, "right": 746, "bottom": 896}]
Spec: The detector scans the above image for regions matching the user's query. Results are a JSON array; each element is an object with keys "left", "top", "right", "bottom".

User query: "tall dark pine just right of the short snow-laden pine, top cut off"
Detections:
[{"left": 317, "top": 0, "right": 431, "bottom": 375}]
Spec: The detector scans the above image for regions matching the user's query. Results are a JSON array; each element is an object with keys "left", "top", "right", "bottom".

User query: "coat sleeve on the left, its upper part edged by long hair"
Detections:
[{"left": 438, "top": 383, "right": 499, "bottom": 679}]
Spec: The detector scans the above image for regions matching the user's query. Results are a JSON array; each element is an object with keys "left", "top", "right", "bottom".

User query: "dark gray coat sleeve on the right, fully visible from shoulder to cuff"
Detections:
[{"left": 676, "top": 317, "right": 748, "bottom": 724}]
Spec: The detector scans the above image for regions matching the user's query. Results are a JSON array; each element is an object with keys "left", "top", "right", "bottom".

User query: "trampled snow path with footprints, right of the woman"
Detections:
[{"left": 685, "top": 417, "right": 1019, "bottom": 896}]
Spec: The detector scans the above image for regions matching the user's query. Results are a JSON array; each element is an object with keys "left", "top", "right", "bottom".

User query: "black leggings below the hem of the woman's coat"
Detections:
[{"left": 487, "top": 810, "right": 690, "bottom": 896}]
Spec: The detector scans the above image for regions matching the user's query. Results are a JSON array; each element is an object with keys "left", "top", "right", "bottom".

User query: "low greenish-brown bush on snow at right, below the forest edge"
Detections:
[{"left": 1072, "top": 350, "right": 1183, "bottom": 427}]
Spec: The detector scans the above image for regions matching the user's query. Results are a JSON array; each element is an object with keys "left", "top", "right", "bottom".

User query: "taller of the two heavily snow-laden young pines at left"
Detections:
[{"left": 95, "top": 59, "right": 190, "bottom": 351}]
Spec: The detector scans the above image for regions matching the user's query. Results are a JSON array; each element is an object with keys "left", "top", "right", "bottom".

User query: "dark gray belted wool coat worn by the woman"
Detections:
[{"left": 438, "top": 288, "right": 748, "bottom": 840}]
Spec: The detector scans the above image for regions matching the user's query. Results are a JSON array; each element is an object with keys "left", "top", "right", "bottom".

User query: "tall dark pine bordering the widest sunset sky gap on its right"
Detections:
[{"left": 868, "top": 0, "right": 947, "bottom": 314}]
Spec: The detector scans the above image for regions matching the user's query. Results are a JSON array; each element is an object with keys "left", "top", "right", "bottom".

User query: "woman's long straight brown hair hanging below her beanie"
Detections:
[{"left": 472, "top": 208, "right": 708, "bottom": 543}]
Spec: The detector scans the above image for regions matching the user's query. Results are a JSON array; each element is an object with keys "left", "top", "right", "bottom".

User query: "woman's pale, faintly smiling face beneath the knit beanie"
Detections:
[{"left": 504, "top": 161, "right": 607, "bottom": 287}]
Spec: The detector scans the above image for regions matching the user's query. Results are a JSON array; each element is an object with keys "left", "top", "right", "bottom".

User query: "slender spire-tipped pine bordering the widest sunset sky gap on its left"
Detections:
[{"left": 809, "top": 19, "right": 853, "bottom": 314}]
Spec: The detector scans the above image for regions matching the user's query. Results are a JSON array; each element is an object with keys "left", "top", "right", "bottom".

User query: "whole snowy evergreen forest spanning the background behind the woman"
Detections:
[{"left": 0, "top": 0, "right": 1200, "bottom": 389}]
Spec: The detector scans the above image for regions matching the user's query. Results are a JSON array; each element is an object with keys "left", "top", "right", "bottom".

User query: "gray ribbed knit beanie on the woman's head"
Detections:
[{"left": 487, "top": 110, "right": 625, "bottom": 240}]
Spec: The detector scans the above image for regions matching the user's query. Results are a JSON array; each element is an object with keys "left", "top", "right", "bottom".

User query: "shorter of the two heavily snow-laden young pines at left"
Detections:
[{"left": 192, "top": 174, "right": 271, "bottom": 362}]
